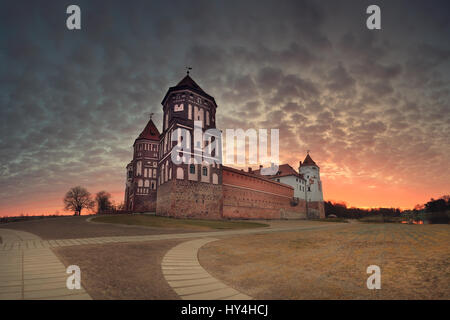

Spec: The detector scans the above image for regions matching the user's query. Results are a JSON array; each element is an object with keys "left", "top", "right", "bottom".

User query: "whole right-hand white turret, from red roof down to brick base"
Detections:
[{"left": 298, "top": 152, "right": 325, "bottom": 218}]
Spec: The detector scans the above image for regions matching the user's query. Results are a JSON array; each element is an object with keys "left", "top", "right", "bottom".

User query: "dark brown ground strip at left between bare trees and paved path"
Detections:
[{"left": 0, "top": 216, "right": 206, "bottom": 240}]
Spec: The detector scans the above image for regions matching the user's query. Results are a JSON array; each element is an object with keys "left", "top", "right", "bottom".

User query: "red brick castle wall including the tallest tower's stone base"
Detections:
[{"left": 156, "top": 167, "right": 312, "bottom": 219}]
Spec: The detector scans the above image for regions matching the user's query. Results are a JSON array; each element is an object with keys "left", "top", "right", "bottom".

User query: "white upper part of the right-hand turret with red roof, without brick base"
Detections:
[{"left": 298, "top": 152, "right": 323, "bottom": 202}]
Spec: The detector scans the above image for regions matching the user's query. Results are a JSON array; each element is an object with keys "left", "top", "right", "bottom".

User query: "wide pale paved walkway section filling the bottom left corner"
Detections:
[{"left": 0, "top": 229, "right": 91, "bottom": 300}]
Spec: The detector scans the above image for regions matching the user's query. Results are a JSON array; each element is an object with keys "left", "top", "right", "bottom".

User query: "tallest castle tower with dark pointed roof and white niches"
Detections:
[{"left": 156, "top": 74, "right": 222, "bottom": 218}]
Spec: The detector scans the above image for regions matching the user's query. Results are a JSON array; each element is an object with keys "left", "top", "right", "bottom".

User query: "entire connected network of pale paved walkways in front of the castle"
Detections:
[{"left": 0, "top": 223, "right": 343, "bottom": 299}]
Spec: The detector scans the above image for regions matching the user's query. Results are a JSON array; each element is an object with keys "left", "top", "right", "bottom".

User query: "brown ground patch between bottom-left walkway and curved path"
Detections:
[{"left": 52, "top": 240, "right": 180, "bottom": 300}]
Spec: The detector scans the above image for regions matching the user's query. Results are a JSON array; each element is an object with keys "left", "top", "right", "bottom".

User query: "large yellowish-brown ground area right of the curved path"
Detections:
[{"left": 199, "top": 224, "right": 450, "bottom": 299}]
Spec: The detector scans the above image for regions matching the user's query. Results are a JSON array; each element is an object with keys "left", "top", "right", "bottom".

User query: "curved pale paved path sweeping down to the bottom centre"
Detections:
[{"left": 161, "top": 238, "right": 251, "bottom": 300}]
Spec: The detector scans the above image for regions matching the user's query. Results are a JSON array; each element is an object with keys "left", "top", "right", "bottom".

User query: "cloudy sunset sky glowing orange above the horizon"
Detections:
[{"left": 0, "top": 0, "right": 450, "bottom": 216}]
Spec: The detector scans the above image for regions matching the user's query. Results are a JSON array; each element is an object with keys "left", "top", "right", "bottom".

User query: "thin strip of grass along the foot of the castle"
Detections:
[{"left": 91, "top": 214, "right": 269, "bottom": 230}]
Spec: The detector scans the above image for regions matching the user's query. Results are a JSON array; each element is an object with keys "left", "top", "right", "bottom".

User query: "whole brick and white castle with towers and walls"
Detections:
[{"left": 125, "top": 73, "right": 325, "bottom": 219}]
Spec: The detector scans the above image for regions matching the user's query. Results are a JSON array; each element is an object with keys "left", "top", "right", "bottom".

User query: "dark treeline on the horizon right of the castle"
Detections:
[{"left": 325, "top": 195, "right": 450, "bottom": 223}]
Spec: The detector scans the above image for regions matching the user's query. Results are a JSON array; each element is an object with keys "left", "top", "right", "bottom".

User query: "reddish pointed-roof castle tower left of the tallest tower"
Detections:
[{"left": 125, "top": 118, "right": 159, "bottom": 212}]
